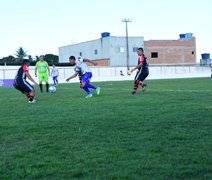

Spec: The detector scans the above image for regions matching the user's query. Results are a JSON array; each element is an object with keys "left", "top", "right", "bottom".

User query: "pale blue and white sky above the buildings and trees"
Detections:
[{"left": 0, "top": 0, "right": 212, "bottom": 61}]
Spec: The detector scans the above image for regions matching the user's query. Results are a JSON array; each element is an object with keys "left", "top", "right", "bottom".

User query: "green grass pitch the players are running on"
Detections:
[{"left": 0, "top": 78, "right": 212, "bottom": 180}]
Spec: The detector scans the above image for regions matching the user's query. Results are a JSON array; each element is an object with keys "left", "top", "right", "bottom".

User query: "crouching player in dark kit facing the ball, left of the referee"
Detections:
[{"left": 13, "top": 60, "right": 38, "bottom": 103}]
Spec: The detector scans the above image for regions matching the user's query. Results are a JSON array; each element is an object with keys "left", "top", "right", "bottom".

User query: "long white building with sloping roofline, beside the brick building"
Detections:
[{"left": 59, "top": 34, "right": 144, "bottom": 66}]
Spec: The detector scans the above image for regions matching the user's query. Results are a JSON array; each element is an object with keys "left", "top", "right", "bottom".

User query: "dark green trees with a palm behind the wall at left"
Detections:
[{"left": 0, "top": 47, "right": 59, "bottom": 65}]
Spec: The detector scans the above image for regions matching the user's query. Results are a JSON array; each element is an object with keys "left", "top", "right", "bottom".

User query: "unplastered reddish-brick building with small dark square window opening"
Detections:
[{"left": 144, "top": 34, "right": 196, "bottom": 64}]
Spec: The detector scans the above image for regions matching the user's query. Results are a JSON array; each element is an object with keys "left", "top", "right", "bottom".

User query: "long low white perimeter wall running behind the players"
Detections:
[{"left": 0, "top": 65, "right": 211, "bottom": 83}]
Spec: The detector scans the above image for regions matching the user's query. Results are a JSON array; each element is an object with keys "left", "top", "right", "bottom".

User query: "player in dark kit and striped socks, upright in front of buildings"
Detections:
[{"left": 131, "top": 48, "right": 149, "bottom": 94}]
